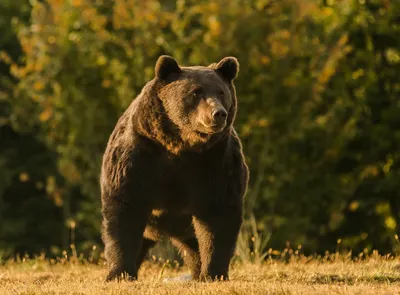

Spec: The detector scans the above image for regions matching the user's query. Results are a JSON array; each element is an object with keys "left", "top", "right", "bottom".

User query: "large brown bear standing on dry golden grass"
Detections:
[{"left": 100, "top": 55, "right": 249, "bottom": 281}]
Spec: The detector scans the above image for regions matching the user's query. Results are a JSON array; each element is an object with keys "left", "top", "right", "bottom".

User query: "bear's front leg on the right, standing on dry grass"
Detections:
[{"left": 193, "top": 208, "right": 243, "bottom": 281}]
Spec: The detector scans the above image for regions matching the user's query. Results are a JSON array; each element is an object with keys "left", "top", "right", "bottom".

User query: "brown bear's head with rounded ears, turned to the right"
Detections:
[{"left": 155, "top": 55, "right": 239, "bottom": 144}]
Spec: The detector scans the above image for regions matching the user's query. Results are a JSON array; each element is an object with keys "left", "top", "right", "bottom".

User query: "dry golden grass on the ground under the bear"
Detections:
[{"left": 0, "top": 256, "right": 400, "bottom": 295}]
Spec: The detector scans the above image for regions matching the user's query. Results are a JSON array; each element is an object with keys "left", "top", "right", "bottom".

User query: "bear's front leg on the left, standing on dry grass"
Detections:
[{"left": 102, "top": 199, "right": 148, "bottom": 281}]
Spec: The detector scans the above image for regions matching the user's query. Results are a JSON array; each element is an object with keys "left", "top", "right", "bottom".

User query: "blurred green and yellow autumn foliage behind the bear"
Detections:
[{"left": 0, "top": 0, "right": 400, "bottom": 258}]
